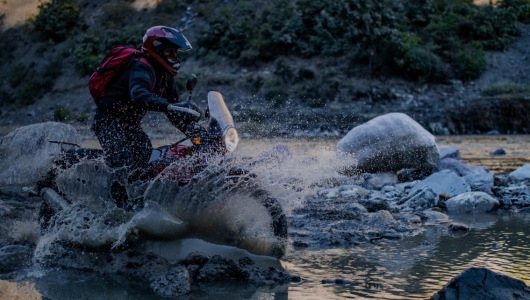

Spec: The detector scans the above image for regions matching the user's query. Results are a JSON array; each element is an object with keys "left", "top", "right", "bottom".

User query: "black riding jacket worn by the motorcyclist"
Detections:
[{"left": 94, "top": 57, "right": 179, "bottom": 124}]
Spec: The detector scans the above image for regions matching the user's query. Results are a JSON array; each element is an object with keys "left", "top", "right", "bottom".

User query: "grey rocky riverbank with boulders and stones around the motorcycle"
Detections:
[{"left": 0, "top": 114, "right": 530, "bottom": 299}]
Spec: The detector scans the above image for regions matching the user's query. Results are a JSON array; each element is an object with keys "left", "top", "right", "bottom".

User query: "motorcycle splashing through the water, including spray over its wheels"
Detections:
[{"left": 36, "top": 75, "right": 287, "bottom": 257}]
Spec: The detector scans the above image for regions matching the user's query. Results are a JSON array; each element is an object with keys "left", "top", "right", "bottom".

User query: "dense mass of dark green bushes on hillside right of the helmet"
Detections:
[{"left": 198, "top": 0, "right": 530, "bottom": 81}]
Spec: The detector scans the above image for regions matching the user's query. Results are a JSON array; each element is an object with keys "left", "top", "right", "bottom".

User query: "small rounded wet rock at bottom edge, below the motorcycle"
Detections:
[{"left": 150, "top": 266, "right": 191, "bottom": 298}]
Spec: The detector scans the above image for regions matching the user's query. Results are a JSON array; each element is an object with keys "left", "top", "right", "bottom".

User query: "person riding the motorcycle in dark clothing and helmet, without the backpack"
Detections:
[{"left": 92, "top": 26, "right": 201, "bottom": 182}]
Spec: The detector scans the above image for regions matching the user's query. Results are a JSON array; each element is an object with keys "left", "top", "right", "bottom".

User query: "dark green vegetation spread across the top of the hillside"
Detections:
[{"left": 4, "top": 0, "right": 530, "bottom": 109}]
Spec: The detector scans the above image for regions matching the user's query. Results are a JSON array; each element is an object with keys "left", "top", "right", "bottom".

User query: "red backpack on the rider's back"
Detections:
[{"left": 88, "top": 46, "right": 142, "bottom": 103}]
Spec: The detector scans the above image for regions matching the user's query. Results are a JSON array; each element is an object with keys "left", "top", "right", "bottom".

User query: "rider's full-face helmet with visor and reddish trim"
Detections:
[{"left": 142, "top": 26, "right": 191, "bottom": 76}]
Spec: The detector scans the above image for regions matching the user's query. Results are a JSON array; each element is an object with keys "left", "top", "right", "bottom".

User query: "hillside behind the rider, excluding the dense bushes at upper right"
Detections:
[{"left": 0, "top": 0, "right": 530, "bottom": 135}]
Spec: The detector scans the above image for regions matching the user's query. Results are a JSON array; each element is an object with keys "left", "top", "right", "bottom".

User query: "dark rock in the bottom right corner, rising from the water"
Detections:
[{"left": 430, "top": 268, "right": 530, "bottom": 300}]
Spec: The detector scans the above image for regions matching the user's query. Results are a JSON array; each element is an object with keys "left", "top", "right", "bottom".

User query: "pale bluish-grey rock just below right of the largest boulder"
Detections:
[{"left": 409, "top": 170, "right": 471, "bottom": 197}]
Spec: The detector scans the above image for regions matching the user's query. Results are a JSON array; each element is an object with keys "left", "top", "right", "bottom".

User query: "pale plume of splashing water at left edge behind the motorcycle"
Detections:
[{"left": 0, "top": 122, "right": 81, "bottom": 184}]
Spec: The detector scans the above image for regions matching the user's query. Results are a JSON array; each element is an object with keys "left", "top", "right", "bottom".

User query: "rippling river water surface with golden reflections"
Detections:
[{"left": 0, "top": 135, "right": 530, "bottom": 300}]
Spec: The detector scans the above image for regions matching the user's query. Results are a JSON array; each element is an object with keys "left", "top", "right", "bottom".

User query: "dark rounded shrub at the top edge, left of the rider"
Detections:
[{"left": 33, "top": 0, "right": 79, "bottom": 42}]
